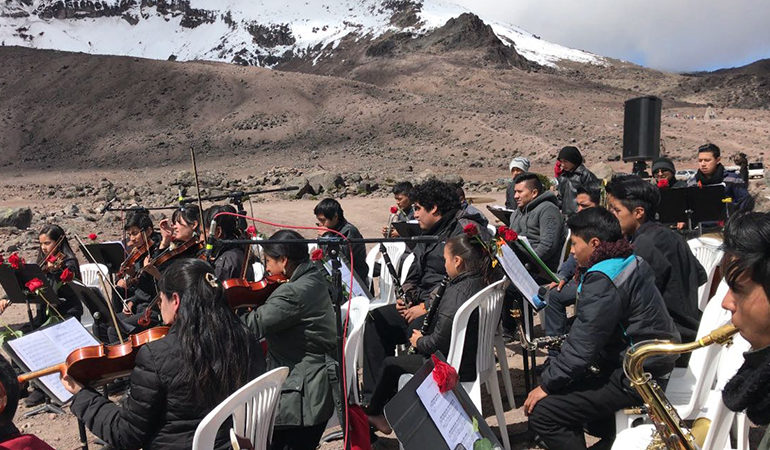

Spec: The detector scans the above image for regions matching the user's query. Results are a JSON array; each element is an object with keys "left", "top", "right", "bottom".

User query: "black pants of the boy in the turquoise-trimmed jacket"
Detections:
[{"left": 529, "top": 369, "right": 642, "bottom": 450}]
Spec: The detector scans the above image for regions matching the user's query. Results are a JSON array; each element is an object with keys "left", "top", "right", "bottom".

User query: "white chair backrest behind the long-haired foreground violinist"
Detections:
[{"left": 192, "top": 367, "right": 289, "bottom": 450}]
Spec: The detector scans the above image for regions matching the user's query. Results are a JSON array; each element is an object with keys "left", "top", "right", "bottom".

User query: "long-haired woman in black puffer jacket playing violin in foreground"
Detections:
[{"left": 62, "top": 259, "right": 265, "bottom": 449}]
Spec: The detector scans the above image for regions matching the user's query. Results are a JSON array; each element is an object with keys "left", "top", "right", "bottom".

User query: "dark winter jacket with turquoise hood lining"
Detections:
[{"left": 541, "top": 255, "right": 680, "bottom": 393}]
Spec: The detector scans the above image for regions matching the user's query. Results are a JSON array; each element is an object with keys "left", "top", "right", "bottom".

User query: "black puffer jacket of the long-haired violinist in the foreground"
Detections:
[{"left": 71, "top": 327, "right": 265, "bottom": 449}]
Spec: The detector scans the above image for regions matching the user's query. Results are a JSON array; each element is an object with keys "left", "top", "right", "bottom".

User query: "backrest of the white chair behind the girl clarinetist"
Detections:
[{"left": 447, "top": 278, "right": 505, "bottom": 374}]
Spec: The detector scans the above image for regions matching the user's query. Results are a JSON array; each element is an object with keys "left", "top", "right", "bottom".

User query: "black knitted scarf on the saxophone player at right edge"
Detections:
[{"left": 722, "top": 347, "right": 770, "bottom": 425}]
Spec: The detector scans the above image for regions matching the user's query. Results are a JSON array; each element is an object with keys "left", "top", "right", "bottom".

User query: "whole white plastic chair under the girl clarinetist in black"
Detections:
[{"left": 447, "top": 280, "right": 511, "bottom": 450}]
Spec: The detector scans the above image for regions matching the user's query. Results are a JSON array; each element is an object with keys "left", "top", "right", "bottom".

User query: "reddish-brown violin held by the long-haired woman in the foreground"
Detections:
[{"left": 17, "top": 327, "right": 169, "bottom": 386}]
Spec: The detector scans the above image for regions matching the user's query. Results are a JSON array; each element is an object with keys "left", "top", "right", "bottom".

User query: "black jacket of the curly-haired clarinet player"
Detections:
[{"left": 404, "top": 210, "right": 462, "bottom": 308}]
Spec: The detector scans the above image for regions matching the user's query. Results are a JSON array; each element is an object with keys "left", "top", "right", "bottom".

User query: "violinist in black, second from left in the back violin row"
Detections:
[{"left": 116, "top": 210, "right": 161, "bottom": 331}]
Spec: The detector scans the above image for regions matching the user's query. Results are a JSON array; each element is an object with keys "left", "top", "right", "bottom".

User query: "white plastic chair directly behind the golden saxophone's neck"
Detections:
[{"left": 615, "top": 281, "right": 730, "bottom": 432}]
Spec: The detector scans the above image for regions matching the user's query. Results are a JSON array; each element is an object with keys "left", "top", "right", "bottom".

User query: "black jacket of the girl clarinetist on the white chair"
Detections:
[{"left": 417, "top": 272, "right": 484, "bottom": 381}]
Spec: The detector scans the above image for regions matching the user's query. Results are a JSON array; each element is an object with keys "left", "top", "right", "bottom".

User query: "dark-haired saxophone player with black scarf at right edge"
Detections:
[{"left": 722, "top": 212, "right": 770, "bottom": 449}]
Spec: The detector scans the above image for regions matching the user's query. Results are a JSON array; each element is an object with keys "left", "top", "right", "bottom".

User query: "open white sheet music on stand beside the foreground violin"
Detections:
[{"left": 8, "top": 317, "right": 99, "bottom": 403}]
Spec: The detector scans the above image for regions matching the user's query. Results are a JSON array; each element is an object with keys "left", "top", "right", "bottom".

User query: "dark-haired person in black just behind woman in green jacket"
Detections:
[{"left": 203, "top": 205, "right": 254, "bottom": 281}]
